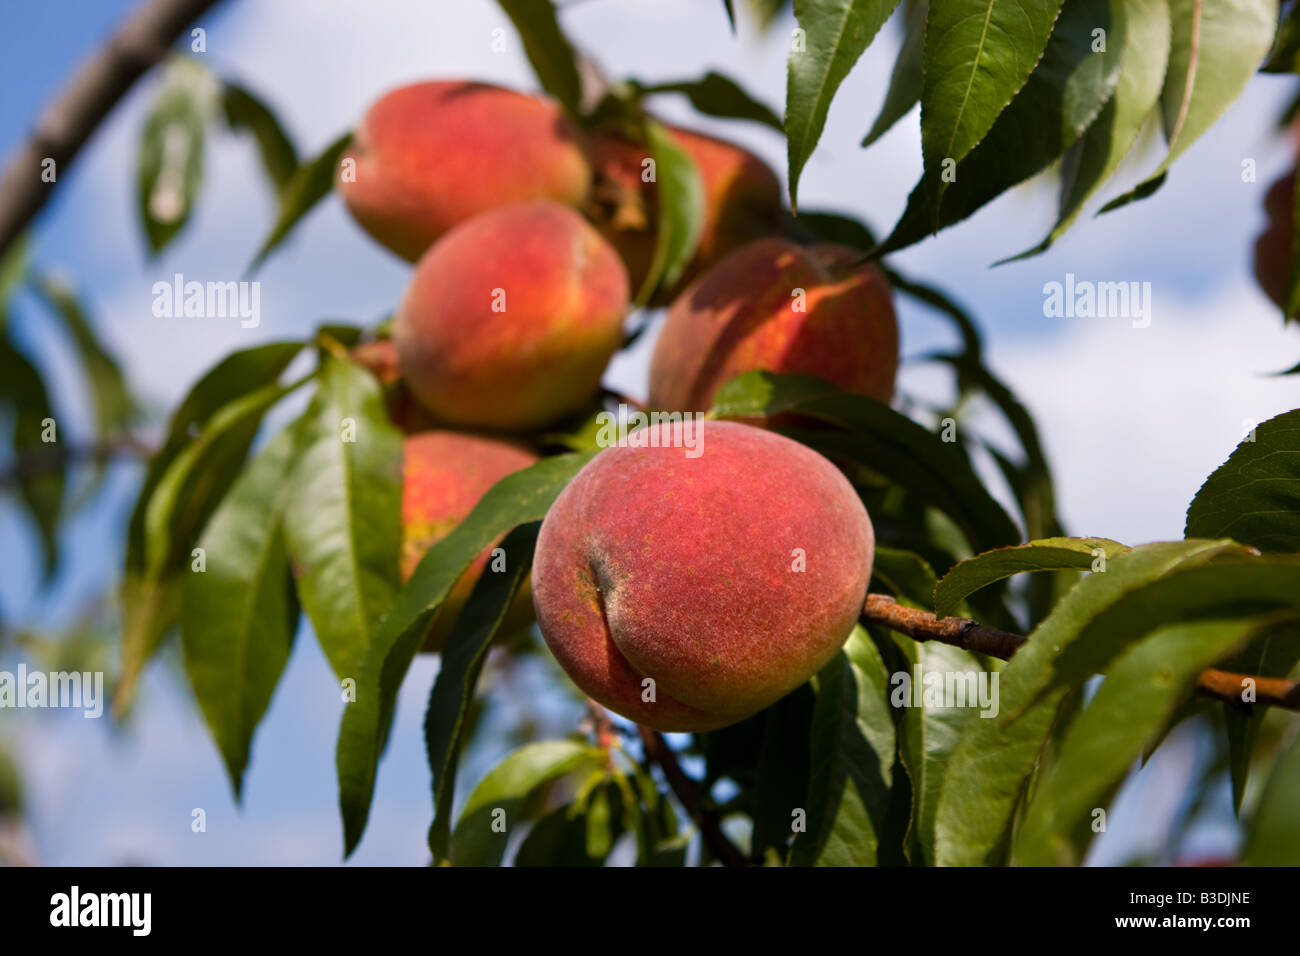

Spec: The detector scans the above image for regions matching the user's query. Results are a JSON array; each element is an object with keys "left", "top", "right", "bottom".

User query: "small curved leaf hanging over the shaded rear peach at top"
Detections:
[{"left": 637, "top": 120, "right": 705, "bottom": 304}]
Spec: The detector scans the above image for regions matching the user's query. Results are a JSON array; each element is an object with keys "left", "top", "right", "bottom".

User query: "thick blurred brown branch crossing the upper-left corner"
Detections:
[{"left": 0, "top": 0, "right": 218, "bottom": 254}]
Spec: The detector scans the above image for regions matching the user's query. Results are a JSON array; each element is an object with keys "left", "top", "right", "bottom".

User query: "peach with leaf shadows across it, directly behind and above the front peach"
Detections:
[{"left": 650, "top": 239, "right": 898, "bottom": 411}]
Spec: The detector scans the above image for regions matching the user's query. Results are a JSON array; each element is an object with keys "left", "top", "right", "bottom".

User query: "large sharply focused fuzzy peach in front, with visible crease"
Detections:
[{"left": 532, "top": 421, "right": 874, "bottom": 731}]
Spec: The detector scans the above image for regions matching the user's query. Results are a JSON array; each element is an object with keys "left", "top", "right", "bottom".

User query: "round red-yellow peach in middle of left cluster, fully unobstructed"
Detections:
[{"left": 393, "top": 202, "right": 628, "bottom": 431}]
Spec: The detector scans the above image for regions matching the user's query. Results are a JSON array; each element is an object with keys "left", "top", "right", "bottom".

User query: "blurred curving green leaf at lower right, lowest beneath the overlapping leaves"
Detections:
[{"left": 1015, "top": 618, "right": 1274, "bottom": 866}]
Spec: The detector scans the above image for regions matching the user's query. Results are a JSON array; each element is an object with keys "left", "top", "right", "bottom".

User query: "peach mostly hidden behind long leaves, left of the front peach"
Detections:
[{"left": 402, "top": 432, "right": 537, "bottom": 652}]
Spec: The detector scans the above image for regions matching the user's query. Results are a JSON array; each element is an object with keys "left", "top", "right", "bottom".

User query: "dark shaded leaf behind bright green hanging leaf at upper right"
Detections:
[{"left": 876, "top": 0, "right": 1123, "bottom": 254}]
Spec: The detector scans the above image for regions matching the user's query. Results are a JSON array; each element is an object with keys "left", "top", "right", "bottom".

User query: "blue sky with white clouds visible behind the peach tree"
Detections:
[{"left": 0, "top": 0, "right": 1300, "bottom": 864}]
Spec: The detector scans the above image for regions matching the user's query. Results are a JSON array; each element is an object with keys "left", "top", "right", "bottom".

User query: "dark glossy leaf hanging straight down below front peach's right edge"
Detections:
[{"left": 790, "top": 624, "right": 896, "bottom": 866}]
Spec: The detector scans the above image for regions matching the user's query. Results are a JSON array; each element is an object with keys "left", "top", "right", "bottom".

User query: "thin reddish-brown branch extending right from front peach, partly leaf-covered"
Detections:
[{"left": 862, "top": 594, "right": 1300, "bottom": 710}]
